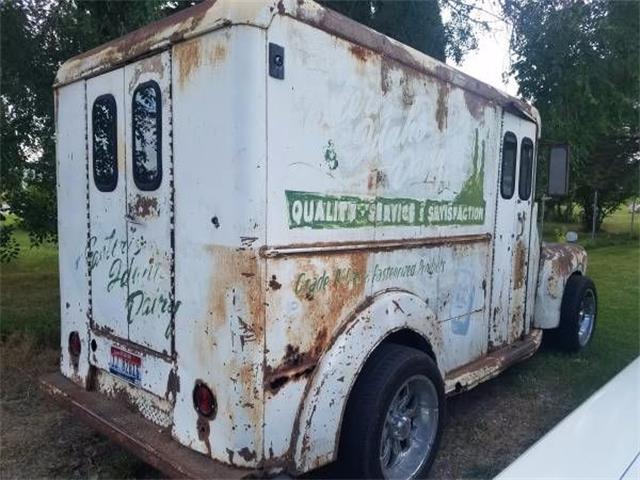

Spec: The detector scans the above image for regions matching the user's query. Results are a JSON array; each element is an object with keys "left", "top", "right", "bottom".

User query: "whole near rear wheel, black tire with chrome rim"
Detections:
[{"left": 340, "top": 344, "right": 445, "bottom": 478}]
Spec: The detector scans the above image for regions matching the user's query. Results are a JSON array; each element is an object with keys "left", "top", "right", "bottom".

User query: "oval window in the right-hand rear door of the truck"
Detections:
[{"left": 131, "top": 81, "right": 162, "bottom": 190}]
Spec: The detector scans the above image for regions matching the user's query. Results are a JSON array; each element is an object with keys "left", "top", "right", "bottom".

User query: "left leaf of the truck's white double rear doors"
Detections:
[{"left": 86, "top": 69, "right": 129, "bottom": 339}]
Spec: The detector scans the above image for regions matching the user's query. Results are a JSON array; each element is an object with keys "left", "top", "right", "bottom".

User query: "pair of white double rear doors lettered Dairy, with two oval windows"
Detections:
[{"left": 86, "top": 52, "right": 177, "bottom": 362}]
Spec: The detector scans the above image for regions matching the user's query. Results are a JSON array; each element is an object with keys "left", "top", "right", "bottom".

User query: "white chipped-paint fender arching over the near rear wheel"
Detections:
[{"left": 291, "top": 290, "right": 444, "bottom": 473}]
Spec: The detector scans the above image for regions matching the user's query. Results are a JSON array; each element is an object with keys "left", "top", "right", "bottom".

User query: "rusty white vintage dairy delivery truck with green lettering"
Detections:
[{"left": 43, "top": 0, "right": 596, "bottom": 478}]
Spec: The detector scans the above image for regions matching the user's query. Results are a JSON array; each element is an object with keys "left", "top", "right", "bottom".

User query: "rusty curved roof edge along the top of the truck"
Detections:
[{"left": 54, "top": 0, "right": 540, "bottom": 125}]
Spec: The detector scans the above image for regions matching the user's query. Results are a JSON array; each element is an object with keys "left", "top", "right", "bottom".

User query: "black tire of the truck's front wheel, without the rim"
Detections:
[{"left": 554, "top": 275, "right": 598, "bottom": 352}]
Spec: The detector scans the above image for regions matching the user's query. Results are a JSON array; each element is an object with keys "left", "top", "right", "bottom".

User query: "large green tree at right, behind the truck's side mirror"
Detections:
[{"left": 504, "top": 0, "right": 640, "bottom": 228}]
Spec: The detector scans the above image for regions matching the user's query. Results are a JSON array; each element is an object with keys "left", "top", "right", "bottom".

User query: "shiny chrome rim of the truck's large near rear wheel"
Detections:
[{"left": 380, "top": 375, "right": 439, "bottom": 478}]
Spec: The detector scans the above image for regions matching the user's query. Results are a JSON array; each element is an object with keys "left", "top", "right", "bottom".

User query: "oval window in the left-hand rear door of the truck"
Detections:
[{"left": 91, "top": 95, "right": 118, "bottom": 192}]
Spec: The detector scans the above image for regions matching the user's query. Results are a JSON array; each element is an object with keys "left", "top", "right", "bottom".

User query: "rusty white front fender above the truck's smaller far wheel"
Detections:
[{"left": 533, "top": 243, "right": 587, "bottom": 329}]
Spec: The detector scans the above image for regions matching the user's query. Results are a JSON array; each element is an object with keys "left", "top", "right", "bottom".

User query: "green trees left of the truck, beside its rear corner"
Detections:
[{"left": 0, "top": 0, "right": 165, "bottom": 261}]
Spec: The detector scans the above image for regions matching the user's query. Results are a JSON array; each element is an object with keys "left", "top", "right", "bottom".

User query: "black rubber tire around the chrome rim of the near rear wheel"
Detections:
[{"left": 339, "top": 344, "right": 445, "bottom": 478}]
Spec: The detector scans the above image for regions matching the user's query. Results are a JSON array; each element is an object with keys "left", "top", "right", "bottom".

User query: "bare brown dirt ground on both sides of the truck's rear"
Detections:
[{"left": 0, "top": 341, "right": 571, "bottom": 479}]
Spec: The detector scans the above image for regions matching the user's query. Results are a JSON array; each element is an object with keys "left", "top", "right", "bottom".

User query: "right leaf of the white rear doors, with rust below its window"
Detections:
[{"left": 124, "top": 52, "right": 175, "bottom": 353}]
